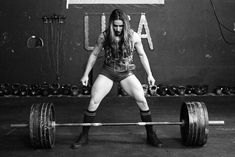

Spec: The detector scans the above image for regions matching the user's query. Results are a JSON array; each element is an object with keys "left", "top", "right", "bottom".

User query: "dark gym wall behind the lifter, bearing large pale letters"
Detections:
[{"left": 0, "top": 0, "right": 235, "bottom": 91}]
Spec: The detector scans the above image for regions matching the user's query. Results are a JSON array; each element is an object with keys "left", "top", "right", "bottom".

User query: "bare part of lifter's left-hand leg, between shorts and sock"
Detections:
[{"left": 88, "top": 75, "right": 113, "bottom": 111}]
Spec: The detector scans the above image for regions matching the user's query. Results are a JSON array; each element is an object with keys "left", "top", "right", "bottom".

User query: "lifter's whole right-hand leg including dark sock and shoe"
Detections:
[{"left": 120, "top": 75, "right": 162, "bottom": 147}]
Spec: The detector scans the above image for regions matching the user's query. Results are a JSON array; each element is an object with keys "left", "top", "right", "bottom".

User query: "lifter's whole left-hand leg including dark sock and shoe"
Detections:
[{"left": 71, "top": 75, "right": 113, "bottom": 149}]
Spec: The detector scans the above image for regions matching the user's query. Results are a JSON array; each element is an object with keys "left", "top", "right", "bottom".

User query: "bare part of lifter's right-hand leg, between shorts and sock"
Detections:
[{"left": 120, "top": 75, "right": 149, "bottom": 111}]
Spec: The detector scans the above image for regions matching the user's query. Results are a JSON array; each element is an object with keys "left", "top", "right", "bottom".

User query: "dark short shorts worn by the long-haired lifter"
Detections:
[{"left": 100, "top": 65, "right": 134, "bottom": 82}]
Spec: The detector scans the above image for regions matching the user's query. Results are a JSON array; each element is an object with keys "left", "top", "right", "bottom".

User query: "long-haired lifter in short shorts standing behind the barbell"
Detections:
[{"left": 72, "top": 9, "right": 162, "bottom": 149}]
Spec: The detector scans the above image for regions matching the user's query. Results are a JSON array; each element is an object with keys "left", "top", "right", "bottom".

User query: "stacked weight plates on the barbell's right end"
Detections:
[{"left": 180, "top": 102, "right": 209, "bottom": 146}]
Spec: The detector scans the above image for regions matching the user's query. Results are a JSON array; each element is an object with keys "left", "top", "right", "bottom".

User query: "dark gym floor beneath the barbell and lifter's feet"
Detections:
[{"left": 0, "top": 96, "right": 235, "bottom": 157}]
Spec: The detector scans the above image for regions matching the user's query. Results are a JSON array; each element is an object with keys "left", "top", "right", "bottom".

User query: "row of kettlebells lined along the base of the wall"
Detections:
[{"left": 0, "top": 81, "right": 235, "bottom": 97}]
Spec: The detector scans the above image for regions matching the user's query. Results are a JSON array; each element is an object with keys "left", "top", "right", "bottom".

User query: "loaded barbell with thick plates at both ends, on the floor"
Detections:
[{"left": 10, "top": 101, "right": 224, "bottom": 149}]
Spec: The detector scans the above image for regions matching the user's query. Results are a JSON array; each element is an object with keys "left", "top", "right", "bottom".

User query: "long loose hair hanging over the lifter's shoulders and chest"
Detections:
[{"left": 104, "top": 9, "right": 131, "bottom": 57}]
